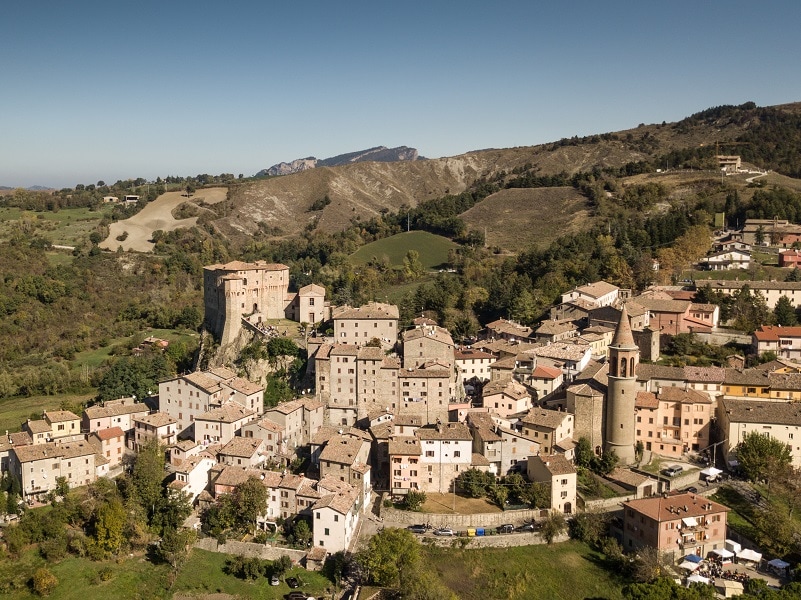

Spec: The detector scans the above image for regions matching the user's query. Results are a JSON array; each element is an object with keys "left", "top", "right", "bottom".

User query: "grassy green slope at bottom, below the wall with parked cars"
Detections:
[{"left": 423, "top": 541, "right": 627, "bottom": 600}]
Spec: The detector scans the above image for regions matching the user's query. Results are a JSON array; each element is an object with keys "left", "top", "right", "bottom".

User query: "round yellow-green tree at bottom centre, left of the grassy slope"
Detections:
[{"left": 356, "top": 528, "right": 420, "bottom": 587}]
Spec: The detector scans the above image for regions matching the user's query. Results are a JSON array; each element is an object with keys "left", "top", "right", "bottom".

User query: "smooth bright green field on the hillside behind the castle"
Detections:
[{"left": 350, "top": 231, "right": 457, "bottom": 269}]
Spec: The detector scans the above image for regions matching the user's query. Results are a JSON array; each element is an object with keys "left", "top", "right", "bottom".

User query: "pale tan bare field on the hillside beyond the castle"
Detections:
[{"left": 99, "top": 187, "right": 228, "bottom": 252}]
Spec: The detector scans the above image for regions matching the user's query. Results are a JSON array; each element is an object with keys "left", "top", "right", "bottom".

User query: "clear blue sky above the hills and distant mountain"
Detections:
[{"left": 0, "top": 0, "right": 801, "bottom": 187}]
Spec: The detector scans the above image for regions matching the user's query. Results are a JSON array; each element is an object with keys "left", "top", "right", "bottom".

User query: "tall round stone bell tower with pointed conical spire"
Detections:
[{"left": 604, "top": 304, "right": 640, "bottom": 464}]
